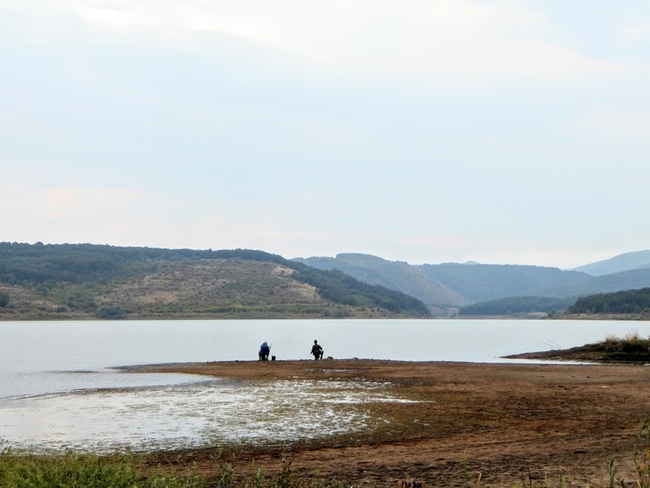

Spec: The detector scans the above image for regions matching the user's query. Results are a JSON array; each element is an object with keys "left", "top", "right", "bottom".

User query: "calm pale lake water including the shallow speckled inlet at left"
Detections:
[{"left": 0, "top": 320, "right": 650, "bottom": 449}]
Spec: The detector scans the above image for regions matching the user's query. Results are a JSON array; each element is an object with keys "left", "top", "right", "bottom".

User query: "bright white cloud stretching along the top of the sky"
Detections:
[{"left": 33, "top": 0, "right": 621, "bottom": 84}]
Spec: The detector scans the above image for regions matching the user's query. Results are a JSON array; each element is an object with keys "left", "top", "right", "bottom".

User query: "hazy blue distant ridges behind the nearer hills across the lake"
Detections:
[{"left": 296, "top": 251, "right": 650, "bottom": 316}]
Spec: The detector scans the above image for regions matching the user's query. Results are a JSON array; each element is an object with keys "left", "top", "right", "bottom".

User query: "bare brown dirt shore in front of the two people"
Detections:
[{"left": 139, "top": 360, "right": 650, "bottom": 487}]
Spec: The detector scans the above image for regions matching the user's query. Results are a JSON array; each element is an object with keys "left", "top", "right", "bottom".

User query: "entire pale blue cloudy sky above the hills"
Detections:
[{"left": 0, "top": 0, "right": 650, "bottom": 268}]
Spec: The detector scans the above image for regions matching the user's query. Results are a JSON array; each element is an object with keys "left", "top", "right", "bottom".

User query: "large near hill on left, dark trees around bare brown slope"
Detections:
[{"left": 0, "top": 242, "right": 430, "bottom": 319}]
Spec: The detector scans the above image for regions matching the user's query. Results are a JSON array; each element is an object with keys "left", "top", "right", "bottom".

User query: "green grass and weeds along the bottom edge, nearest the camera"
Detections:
[{"left": 0, "top": 417, "right": 650, "bottom": 488}]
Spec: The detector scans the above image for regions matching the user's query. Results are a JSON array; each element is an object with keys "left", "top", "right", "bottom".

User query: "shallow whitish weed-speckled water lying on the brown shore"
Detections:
[{"left": 0, "top": 380, "right": 404, "bottom": 451}]
